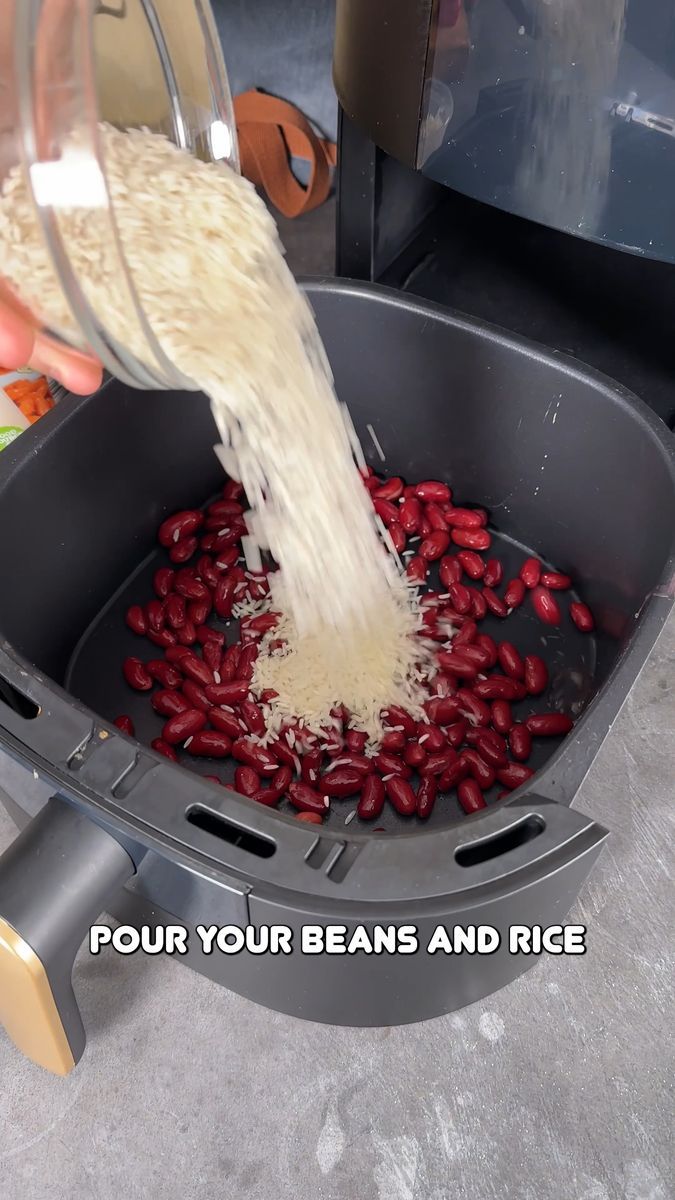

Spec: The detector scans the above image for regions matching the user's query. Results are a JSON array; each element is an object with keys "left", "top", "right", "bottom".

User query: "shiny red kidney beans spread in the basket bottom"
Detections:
[{"left": 115, "top": 468, "right": 593, "bottom": 824}]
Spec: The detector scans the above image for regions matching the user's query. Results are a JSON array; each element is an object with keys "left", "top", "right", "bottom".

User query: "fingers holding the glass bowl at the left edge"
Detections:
[{"left": 0, "top": 286, "right": 103, "bottom": 396}]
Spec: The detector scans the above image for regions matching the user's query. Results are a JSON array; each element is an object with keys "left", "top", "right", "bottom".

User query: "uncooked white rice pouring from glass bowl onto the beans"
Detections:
[{"left": 0, "top": 126, "right": 429, "bottom": 740}]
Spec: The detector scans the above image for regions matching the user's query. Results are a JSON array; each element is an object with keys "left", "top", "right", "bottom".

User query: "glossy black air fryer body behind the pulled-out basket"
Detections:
[{"left": 334, "top": 0, "right": 675, "bottom": 427}]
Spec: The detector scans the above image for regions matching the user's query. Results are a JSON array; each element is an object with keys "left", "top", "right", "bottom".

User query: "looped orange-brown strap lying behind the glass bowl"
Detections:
[{"left": 234, "top": 91, "right": 338, "bottom": 217}]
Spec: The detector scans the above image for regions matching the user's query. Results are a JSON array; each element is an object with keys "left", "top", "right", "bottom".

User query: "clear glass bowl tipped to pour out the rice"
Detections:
[{"left": 0, "top": 0, "right": 239, "bottom": 388}]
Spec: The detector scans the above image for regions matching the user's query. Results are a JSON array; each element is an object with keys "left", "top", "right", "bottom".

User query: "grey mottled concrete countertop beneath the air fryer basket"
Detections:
[{"left": 0, "top": 617, "right": 675, "bottom": 1200}]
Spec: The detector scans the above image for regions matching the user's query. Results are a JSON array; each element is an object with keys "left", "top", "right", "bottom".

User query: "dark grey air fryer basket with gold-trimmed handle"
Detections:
[{"left": 0, "top": 282, "right": 675, "bottom": 1070}]
